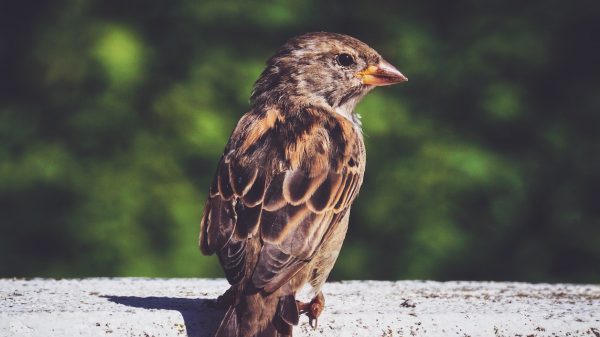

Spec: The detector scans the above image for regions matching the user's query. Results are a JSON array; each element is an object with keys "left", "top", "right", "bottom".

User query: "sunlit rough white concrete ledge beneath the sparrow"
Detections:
[{"left": 0, "top": 278, "right": 600, "bottom": 337}]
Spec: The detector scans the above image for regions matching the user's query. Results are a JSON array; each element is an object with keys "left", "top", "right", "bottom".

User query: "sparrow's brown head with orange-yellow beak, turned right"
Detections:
[{"left": 252, "top": 32, "right": 408, "bottom": 114}]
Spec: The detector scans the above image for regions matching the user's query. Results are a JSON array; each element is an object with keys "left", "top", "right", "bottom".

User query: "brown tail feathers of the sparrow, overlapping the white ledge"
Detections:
[{"left": 215, "top": 291, "right": 300, "bottom": 337}]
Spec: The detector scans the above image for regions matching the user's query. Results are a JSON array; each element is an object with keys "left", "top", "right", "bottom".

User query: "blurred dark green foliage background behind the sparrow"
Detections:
[{"left": 0, "top": 0, "right": 600, "bottom": 282}]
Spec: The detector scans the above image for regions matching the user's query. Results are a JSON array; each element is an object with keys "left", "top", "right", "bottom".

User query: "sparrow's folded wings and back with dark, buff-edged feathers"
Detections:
[{"left": 200, "top": 106, "right": 364, "bottom": 292}]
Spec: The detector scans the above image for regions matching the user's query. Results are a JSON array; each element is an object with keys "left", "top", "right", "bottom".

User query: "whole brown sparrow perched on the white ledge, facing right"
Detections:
[{"left": 200, "top": 32, "right": 407, "bottom": 337}]
